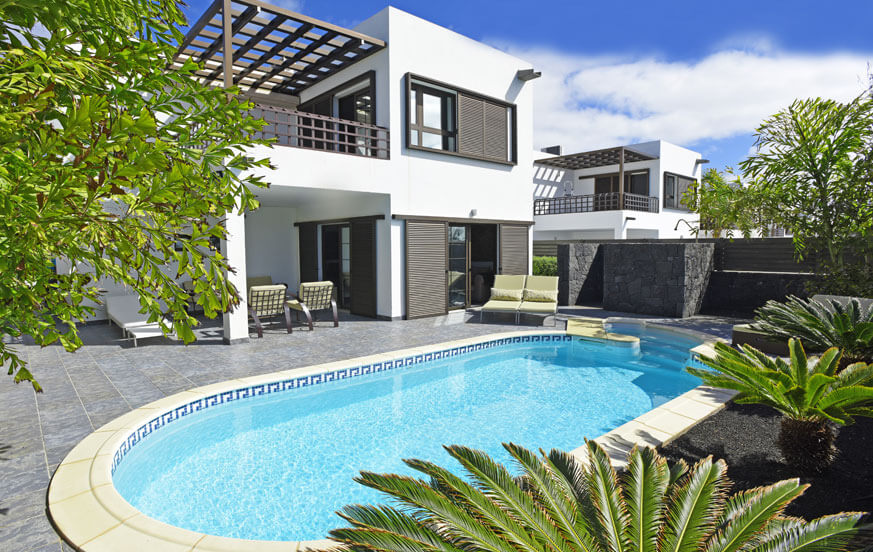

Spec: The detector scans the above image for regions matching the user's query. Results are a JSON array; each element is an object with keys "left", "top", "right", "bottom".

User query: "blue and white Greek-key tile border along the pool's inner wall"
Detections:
[{"left": 111, "top": 334, "right": 574, "bottom": 475}]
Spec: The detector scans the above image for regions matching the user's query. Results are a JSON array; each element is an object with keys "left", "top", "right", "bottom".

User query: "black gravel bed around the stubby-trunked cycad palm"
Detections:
[{"left": 661, "top": 403, "right": 873, "bottom": 522}]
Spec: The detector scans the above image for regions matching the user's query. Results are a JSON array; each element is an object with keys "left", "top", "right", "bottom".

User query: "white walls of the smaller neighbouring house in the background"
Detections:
[{"left": 533, "top": 140, "right": 702, "bottom": 241}]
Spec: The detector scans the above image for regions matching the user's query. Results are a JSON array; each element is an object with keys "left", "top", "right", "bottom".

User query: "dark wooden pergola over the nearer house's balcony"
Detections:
[{"left": 173, "top": 0, "right": 385, "bottom": 96}]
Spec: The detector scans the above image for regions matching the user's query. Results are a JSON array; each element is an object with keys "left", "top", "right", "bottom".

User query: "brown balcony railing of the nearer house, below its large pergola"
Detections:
[{"left": 250, "top": 104, "right": 389, "bottom": 159}]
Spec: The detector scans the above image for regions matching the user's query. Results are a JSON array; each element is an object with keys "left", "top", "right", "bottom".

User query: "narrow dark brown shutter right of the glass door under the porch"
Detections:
[{"left": 349, "top": 220, "right": 378, "bottom": 318}]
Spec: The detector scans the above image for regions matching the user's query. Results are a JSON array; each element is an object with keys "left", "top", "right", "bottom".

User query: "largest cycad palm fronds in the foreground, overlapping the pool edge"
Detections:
[{"left": 330, "top": 441, "right": 861, "bottom": 552}]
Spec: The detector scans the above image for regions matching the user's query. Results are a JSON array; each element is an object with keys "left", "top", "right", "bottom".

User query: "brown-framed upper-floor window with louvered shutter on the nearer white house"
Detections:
[{"left": 404, "top": 73, "right": 518, "bottom": 167}]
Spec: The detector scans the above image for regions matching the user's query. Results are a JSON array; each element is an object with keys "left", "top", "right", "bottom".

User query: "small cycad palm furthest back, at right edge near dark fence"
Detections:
[{"left": 752, "top": 296, "right": 873, "bottom": 364}]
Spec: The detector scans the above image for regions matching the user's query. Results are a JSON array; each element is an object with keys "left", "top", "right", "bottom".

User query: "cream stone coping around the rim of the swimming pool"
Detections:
[{"left": 46, "top": 317, "right": 734, "bottom": 552}]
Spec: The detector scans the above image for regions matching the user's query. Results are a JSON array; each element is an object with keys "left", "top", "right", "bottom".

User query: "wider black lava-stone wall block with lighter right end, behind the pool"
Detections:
[{"left": 601, "top": 243, "right": 715, "bottom": 317}]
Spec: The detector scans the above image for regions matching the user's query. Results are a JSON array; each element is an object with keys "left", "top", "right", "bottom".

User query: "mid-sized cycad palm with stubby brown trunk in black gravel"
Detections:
[{"left": 686, "top": 338, "right": 873, "bottom": 473}]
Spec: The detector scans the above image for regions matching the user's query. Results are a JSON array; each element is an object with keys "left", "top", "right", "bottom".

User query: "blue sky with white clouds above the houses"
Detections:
[{"left": 186, "top": 0, "right": 873, "bottom": 169}]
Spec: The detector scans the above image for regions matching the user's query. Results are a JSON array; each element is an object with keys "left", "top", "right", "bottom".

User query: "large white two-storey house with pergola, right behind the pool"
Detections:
[{"left": 169, "top": 0, "right": 537, "bottom": 341}]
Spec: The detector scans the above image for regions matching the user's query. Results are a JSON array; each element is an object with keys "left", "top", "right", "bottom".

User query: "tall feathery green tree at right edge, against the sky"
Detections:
[{"left": 740, "top": 95, "right": 873, "bottom": 269}]
